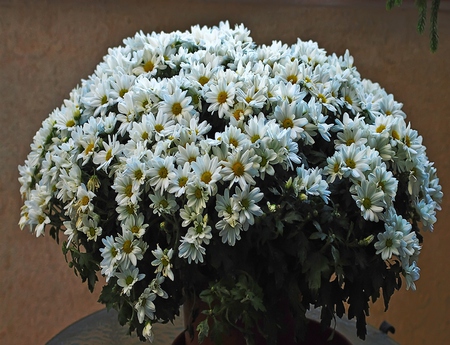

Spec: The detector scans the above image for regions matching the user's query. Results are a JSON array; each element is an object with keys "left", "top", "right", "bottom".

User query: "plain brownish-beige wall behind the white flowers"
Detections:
[{"left": 0, "top": 0, "right": 450, "bottom": 345}]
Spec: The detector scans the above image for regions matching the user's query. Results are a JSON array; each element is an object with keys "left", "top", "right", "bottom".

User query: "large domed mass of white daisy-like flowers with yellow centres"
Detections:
[{"left": 19, "top": 23, "right": 442, "bottom": 340}]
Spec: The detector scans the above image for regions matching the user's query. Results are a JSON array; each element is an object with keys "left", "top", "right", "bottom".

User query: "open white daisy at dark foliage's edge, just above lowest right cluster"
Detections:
[{"left": 352, "top": 179, "right": 386, "bottom": 222}]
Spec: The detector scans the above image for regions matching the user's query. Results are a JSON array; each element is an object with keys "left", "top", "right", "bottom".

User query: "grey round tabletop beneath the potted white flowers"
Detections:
[{"left": 47, "top": 309, "right": 398, "bottom": 345}]
